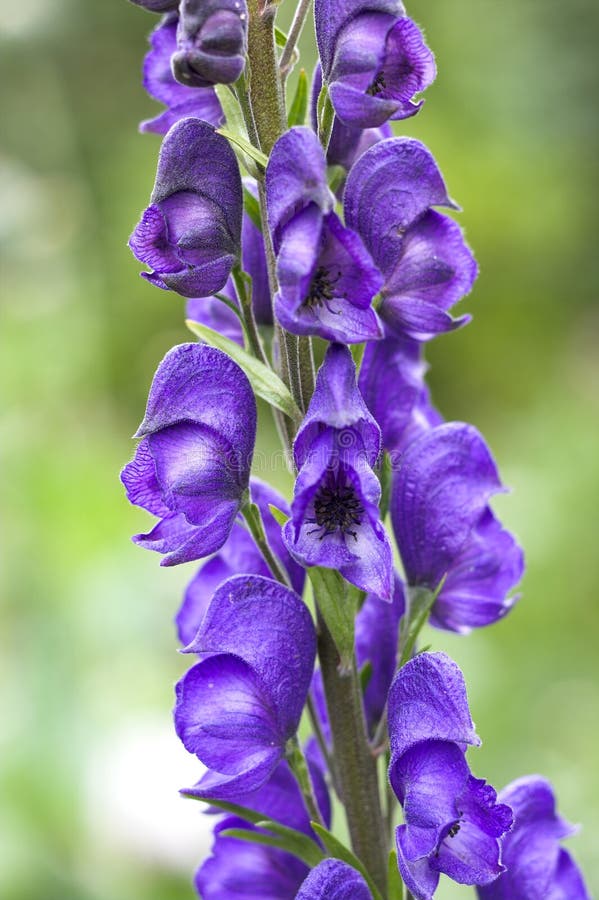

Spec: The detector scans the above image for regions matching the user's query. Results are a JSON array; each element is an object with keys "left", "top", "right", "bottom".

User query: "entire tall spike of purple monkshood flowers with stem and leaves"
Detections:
[{"left": 122, "top": 0, "right": 588, "bottom": 900}]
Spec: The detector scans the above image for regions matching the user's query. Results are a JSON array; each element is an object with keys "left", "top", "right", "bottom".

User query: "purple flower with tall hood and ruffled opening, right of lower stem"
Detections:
[{"left": 389, "top": 653, "right": 512, "bottom": 900}]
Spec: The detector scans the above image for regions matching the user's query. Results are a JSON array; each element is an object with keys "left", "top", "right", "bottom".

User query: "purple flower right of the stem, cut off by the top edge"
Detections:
[{"left": 314, "top": 0, "right": 437, "bottom": 128}]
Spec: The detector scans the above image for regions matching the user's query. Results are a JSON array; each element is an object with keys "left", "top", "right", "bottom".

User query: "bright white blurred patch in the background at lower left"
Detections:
[{"left": 83, "top": 717, "right": 214, "bottom": 876}]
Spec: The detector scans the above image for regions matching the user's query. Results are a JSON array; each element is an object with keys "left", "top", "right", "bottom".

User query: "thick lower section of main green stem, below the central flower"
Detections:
[{"left": 317, "top": 601, "right": 387, "bottom": 896}]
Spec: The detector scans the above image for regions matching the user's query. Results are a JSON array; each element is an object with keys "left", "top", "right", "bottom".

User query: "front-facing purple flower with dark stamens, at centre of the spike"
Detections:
[{"left": 283, "top": 344, "right": 393, "bottom": 600}]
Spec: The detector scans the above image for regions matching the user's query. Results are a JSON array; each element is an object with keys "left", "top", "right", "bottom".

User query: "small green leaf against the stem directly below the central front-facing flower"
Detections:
[{"left": 308, "top": 566, "right": 357, "bottom": 672}]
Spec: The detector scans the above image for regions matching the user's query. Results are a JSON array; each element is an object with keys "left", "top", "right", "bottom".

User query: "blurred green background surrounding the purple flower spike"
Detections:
[{"left": 0, "top": 0, "right": 599, "bottom": 900}]
